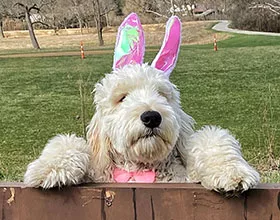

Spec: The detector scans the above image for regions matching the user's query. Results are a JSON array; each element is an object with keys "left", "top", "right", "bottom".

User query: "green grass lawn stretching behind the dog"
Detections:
[{"left": 0, "top": 35, "right": 280, "bottom": 182}]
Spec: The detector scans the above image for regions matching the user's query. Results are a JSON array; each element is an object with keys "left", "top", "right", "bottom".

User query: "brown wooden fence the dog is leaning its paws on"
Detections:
[{"left": 0, "top": 183, "right": 280, "bottom": 220}]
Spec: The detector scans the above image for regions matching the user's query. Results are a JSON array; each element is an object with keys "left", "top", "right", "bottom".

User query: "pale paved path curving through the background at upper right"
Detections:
[{"left": 212, "top": 20, "right": 280, "bottom": 36}]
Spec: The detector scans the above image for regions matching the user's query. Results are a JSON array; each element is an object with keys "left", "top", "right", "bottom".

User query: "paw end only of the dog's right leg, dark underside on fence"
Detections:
[{"left": 201, "top": 161, "right": 260, "bottom": 196}]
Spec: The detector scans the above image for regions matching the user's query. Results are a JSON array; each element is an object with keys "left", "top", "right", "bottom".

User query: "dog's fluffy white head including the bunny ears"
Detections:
[{"left": 88, "top": 13, "right": 195, "bottom": 178}]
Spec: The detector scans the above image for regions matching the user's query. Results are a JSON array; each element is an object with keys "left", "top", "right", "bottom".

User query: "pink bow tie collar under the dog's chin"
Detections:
[{"left": 113, "top": 168, "right": 156, "bottom": 183}]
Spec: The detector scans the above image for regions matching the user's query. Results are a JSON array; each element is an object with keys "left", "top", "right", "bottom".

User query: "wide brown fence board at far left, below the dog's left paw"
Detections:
[{"left": 2, "top": 187, "right": 101, "bottom": 220}]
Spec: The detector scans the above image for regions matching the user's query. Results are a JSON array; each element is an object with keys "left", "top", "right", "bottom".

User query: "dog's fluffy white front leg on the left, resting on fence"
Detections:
[{"left": 24, "top": 135, "right": 90, "bottom": 188}]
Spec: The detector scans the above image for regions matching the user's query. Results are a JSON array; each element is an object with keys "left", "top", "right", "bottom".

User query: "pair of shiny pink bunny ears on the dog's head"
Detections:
[{"left": 113, "top": 13, "right": 181, "bottom": 78}]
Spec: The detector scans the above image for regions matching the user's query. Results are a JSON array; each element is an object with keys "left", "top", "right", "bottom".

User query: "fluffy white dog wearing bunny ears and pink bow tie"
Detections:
[{"left": 24, "top": 13, "right": 259, "bottom": 192}]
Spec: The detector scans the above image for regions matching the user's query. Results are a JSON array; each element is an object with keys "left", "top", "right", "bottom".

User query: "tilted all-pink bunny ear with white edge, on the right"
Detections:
[{"left": 151, "top": 16, "right": 181, "bottom": 77}]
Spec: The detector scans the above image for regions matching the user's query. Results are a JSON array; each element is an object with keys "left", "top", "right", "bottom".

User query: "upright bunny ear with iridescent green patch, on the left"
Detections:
[{"left": 113, "top": 13, "right": 145, "bottom": 70}]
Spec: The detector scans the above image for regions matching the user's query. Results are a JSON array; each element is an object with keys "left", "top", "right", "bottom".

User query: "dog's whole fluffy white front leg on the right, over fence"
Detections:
[{"left": 187, "top": 126, "right": 259, "bottom": 193}]
